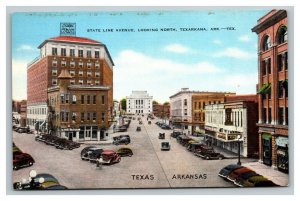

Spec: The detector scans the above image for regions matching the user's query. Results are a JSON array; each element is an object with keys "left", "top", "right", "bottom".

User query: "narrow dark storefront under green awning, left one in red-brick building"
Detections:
[{"left": 262, "top": 133, "right": 272, "bottom": 166}]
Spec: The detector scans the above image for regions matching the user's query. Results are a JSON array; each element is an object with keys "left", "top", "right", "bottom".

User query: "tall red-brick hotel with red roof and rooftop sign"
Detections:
[{"left": 27, "top": 36, "right": 114, "bottom": 139}]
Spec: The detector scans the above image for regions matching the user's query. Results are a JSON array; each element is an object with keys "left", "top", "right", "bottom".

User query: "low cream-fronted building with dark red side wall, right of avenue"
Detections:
[{"left": 205, "top": 95, "right": 258, "bottom": 157}]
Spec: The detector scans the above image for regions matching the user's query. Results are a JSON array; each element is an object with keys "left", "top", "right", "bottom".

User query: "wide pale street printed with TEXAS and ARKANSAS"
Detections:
[{"left": 13, "top": 117, "right": 236, "bottom": 189}]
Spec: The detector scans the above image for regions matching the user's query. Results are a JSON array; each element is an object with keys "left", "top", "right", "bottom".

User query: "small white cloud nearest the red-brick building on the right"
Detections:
[{"left": 213, "top": 47, "right": 256, "bottom": 59}]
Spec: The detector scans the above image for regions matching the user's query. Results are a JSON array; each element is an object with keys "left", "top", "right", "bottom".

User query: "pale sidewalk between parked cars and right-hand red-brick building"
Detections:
[{"left": 242, "top": 162, "right": 289, "bottom": 186}]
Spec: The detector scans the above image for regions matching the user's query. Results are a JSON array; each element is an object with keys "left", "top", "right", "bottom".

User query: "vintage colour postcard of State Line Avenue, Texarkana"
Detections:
[{"left": 11, "top": 8, "right": 293, "bottom": 191}]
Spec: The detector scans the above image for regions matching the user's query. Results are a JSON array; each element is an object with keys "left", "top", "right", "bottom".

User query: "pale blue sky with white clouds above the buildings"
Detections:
[{"left": 12, "top": 10, "right": 269, "bottom": 102}]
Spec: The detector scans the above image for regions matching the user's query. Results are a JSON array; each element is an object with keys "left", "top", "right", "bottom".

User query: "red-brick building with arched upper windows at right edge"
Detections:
[{"left": 252, "top": 10, "right": 288, "bottom": 172}]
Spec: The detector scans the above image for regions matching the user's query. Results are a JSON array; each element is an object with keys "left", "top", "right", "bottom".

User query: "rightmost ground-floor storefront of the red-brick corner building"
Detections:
[{"left": 275, "top": 136, "right": 289, "bottom": 173}]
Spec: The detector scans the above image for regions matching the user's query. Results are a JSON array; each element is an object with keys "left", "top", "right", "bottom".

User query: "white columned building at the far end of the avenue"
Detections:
[{"left": 126, "top": 91, "right": 153, "bottom": 114}]
